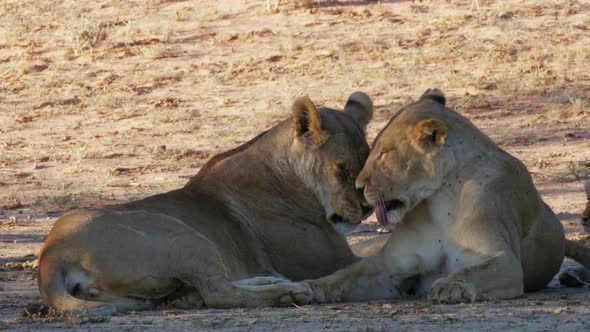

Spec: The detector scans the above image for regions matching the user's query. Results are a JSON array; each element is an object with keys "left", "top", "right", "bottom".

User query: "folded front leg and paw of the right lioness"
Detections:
[{"left": 428, "top": 253, "right": 523, "bottom": 304}]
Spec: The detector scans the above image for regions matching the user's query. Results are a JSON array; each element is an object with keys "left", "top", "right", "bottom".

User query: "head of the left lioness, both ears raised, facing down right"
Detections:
[{"left": 290, "top": 92, "right": 373, "bottom": 233}]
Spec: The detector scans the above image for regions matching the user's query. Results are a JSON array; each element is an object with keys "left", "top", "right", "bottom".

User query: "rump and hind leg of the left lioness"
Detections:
[{"left": 39, "top": 210, "right": 307, "bottom": 310}]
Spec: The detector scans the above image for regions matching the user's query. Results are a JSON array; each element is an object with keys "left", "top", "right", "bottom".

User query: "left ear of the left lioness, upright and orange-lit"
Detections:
[{"left": 292, "top": 96, "right": 328, "bottom": 146}]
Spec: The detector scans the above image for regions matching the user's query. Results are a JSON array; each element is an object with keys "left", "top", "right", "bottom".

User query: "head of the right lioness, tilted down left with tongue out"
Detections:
[{"left": 356, "top": 90, "right": 451, "bottom": 228}]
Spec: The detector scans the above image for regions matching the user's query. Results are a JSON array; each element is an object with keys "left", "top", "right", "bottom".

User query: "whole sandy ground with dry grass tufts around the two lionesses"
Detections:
[{"left": 0, "top": 0, "right": 590, "bottom": 331}]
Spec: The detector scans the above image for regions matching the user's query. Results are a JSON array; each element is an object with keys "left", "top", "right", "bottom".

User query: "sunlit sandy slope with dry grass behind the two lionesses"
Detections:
[{"left": 0, "top": 1, "right": 590, "bottom": 213}]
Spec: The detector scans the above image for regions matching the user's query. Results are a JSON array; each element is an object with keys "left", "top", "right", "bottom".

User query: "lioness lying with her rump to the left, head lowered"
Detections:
[{"left": 39, "top": 92, "right": 373, "bottom": 312}]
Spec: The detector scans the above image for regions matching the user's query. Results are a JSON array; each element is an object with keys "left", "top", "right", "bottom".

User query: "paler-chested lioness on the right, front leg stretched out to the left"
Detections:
[{"left": 281, "top": 90, "right": 581, "bottom": 303}]
